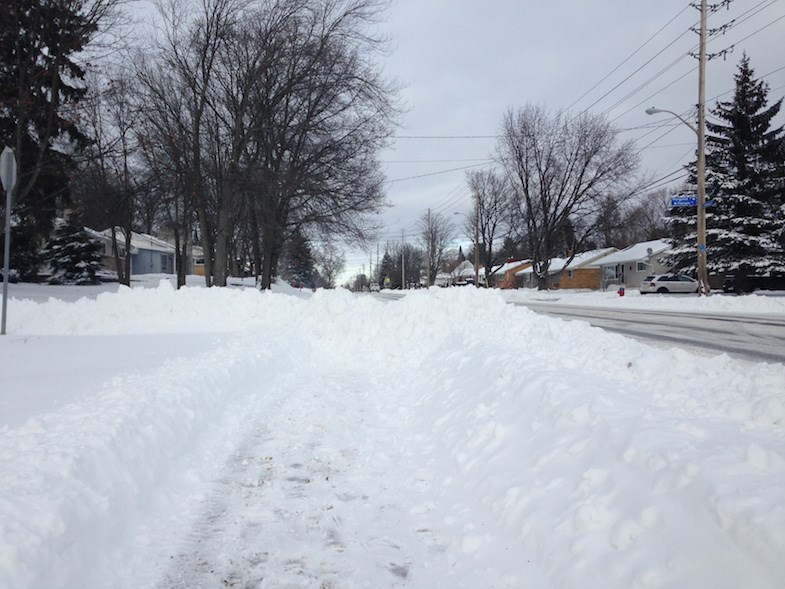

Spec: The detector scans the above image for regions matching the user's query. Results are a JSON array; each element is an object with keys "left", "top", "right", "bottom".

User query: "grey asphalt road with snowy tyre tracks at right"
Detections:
[{"left": 514, "top": 302, "right": 785, "bottom": 363}]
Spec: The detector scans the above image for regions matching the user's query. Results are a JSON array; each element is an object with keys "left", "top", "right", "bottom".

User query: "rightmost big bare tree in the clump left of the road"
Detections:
[{"left": 248, "top": 0, "right": 396, "bottom": 288}]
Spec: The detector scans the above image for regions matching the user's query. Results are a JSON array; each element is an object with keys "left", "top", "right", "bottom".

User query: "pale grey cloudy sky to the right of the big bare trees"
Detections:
[{"left": 345, "top": 0, "right": 785, "bottom": 276}]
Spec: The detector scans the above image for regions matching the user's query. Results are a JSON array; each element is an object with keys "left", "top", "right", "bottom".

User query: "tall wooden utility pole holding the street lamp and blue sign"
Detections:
[{"left": 697, "top": 0, "right": 710, "bottom": 296}]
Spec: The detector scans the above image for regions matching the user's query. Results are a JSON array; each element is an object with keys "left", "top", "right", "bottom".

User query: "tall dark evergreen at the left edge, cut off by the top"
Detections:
[{"left": 0, "top": 0, "right": 100, "bottom": 277}]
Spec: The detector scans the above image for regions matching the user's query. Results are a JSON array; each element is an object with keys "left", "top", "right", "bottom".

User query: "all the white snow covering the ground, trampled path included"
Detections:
[{"left": 0, "top": 277, "right": 785, "bottom": 589}]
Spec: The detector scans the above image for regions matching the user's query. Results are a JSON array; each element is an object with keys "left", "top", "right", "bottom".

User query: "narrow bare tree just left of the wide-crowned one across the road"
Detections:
[{"left": 466, "top": 170, "right": 513, "bottom": 282}]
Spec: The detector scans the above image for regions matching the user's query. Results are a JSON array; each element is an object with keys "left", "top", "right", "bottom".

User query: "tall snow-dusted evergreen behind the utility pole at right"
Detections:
[{"left": 670, "top": 55, "right": 785, "bottom": 275}]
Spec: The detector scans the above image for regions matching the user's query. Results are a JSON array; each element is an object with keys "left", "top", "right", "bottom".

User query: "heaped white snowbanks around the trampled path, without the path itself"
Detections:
[{"left": 0, "top": 283, "right": 785, "bottom": 588}]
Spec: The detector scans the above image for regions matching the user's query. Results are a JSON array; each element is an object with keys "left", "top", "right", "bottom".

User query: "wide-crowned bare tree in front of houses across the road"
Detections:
[{"left": 497, "top": 105, "right": 638, "bottom": 289}]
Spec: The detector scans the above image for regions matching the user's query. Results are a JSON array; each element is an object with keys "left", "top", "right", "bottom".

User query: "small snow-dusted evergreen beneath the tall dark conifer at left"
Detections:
[{"left": 44, "top": 217, "right": 102, "bottom": 284}]
